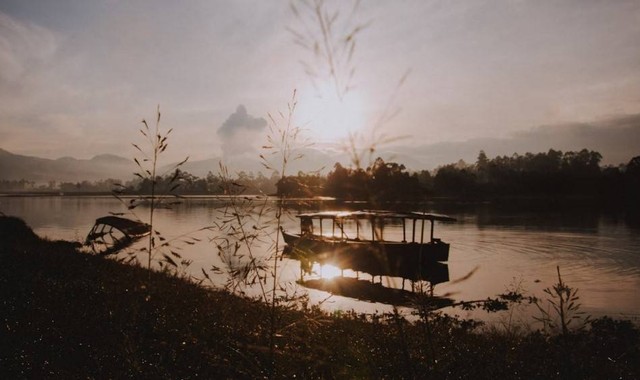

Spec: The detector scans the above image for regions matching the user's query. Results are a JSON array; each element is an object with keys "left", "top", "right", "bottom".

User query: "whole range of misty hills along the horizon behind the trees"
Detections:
[{"left": 0, "top": 114, "right": 640, "bottom": 183}]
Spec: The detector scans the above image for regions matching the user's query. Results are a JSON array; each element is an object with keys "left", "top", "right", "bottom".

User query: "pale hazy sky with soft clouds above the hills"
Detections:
[{"left": 0, "top": 0, "right": 640, "bottom": 169}]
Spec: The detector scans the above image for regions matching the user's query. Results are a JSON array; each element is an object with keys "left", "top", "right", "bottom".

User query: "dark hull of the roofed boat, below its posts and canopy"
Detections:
[{"left": 282, "top": 231, "right": 449, "bottom": 280}]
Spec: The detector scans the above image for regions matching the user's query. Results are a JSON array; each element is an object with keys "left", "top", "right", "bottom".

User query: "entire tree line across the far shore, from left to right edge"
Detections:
[{"left": 0, "top": 149, "right": 640, "bottom": 209}]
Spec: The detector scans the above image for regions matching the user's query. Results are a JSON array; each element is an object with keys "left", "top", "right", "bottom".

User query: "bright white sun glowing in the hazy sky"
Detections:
[{"left": 296, "top": 82, "right": 365, "bottom": 142}]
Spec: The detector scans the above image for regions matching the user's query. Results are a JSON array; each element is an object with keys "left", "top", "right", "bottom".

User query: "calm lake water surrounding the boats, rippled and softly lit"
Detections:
[{"left": 0, "top": 196, "right": 640, "bottom": 321}]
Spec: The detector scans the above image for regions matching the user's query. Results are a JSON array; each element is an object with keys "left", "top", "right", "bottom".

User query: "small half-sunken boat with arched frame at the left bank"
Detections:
[{"left": 85, "top": 215, "right": 151, "bottom": 255}]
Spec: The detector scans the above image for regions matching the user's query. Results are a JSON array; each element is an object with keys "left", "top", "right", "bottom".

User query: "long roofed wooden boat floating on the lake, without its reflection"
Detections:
[{"left": 282, "top": 211, "right": 455, "bottom": 280}]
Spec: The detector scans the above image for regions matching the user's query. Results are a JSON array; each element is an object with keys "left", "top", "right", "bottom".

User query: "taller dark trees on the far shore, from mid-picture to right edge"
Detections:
[{"left": 277, "top": 149, "right": 640, "bottom": 204}]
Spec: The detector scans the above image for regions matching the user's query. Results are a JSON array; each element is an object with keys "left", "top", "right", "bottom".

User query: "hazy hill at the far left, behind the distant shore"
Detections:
[{"left": 0, "top": 149, "right": 136, "bottom": 183}]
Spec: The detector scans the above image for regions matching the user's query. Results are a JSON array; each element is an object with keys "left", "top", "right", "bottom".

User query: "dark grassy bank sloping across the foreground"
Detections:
[{"left": 0, "top": 216, "right": 640, "bottom": 379}]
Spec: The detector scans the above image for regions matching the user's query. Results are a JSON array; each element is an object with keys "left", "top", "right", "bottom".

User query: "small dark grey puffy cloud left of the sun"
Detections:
[{"left": 218, "top": 104, "right": 267, "bottom": 158}]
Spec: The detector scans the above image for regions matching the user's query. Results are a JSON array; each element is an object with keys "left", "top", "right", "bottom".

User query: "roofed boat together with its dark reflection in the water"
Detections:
[{"left": 282, "top": 211, "right": 455, "bottom": 307}]
